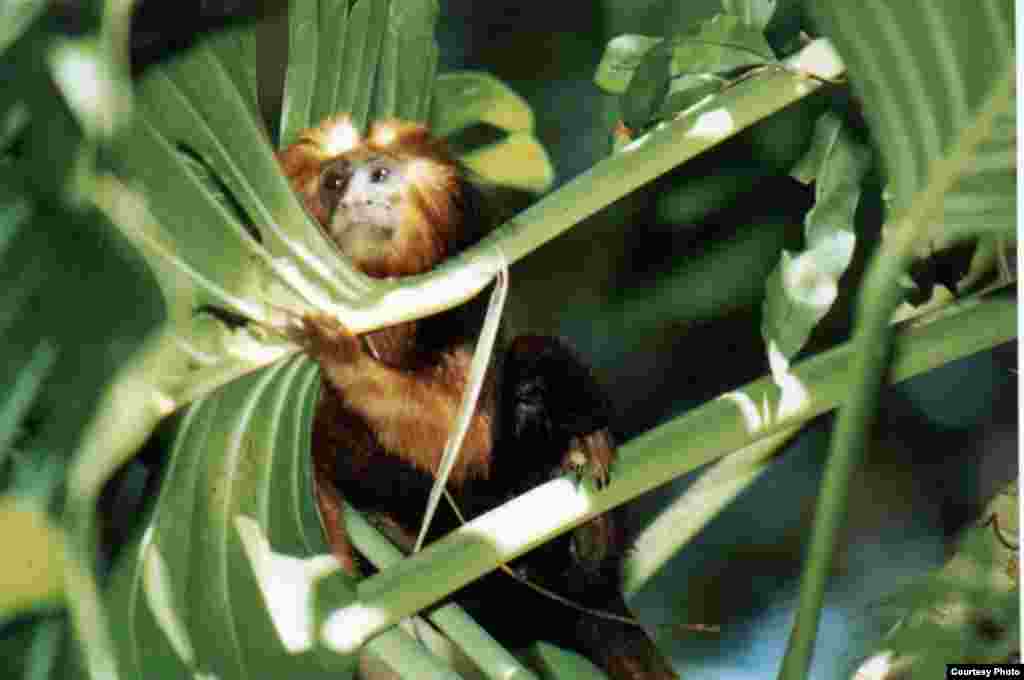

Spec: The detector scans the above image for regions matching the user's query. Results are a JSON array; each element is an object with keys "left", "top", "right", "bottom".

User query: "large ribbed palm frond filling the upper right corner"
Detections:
[{"left": 815, "top": 0, "right": 1016, "bottom": 242}]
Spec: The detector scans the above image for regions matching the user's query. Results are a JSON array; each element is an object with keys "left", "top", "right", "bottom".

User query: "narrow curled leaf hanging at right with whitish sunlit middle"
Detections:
[{"left": 761, "top": 114, "right": 870, "bottom": 358}]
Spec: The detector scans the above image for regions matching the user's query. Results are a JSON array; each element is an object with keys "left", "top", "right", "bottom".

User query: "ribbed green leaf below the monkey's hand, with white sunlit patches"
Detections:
[{"left": 109, "top": 358, "right": 354, "bottom": 679}]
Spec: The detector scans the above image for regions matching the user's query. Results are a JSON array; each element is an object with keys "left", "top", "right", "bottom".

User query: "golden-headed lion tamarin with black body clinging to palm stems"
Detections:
[{"left": 278, "top": 116, "right": 676, "bottom": 680}]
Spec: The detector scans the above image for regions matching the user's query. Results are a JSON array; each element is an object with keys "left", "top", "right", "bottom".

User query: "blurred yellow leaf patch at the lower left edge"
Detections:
[{"left": 0, "top": 496, "right": 65, "bottom": 620}]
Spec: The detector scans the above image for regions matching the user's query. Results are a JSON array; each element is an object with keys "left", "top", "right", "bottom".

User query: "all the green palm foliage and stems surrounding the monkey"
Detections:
[{"left": 0, "top": 0, "right": 1019, "bottom": 678}]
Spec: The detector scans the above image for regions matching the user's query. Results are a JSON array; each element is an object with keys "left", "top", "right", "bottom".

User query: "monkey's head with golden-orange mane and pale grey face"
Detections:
[{"left": 278, "top": 116, "right": 464, "bottom": 278}]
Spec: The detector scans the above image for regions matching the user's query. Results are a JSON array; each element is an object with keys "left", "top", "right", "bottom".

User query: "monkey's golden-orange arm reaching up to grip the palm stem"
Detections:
[{"left": 302, "top": 316, "right": 494, "bottom": 486}]
